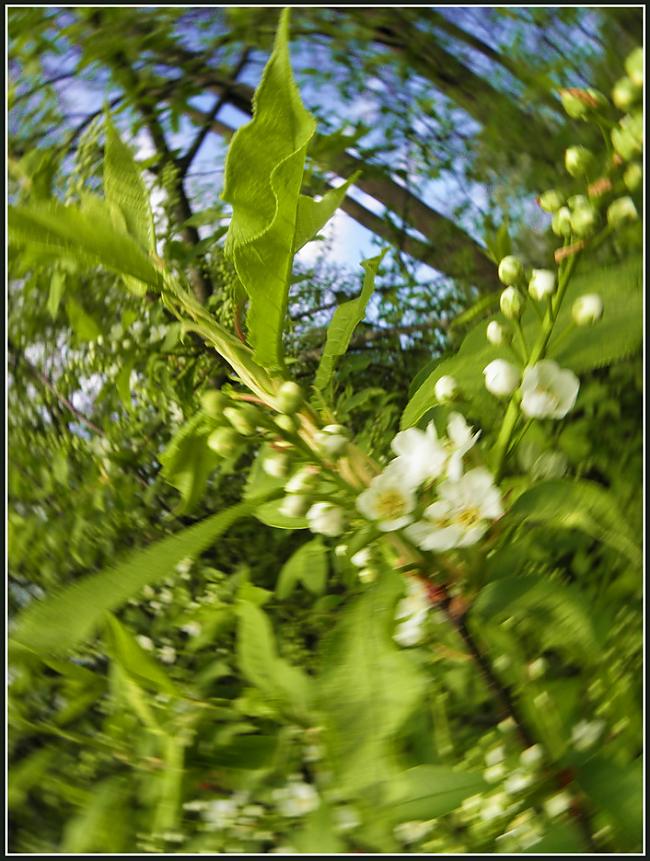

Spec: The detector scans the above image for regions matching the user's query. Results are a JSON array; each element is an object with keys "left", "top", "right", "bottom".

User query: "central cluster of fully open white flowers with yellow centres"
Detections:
[{"left": 357, "top": 413, "right": 503, "bottom": 551}]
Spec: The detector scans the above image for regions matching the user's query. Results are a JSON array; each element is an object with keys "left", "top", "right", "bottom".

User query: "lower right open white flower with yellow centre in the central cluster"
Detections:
[{"left": 407, "top": 467, "right": 503, "bottom": 551}]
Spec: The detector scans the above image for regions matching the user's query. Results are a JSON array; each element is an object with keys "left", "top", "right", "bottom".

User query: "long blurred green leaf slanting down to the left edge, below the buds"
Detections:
[{"left": 11, "top": 500, "right": 258, "bottom": 654}]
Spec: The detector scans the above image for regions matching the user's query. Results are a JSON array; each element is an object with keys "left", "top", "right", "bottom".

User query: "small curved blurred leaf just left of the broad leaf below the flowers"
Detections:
[{"left": 237, "top": 601, "right": 311, "bottom": 720}]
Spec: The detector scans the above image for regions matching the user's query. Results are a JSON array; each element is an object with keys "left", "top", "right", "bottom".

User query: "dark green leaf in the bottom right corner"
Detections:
[{"left": 576, "top": 754, "right": 643, "bottom": 850}]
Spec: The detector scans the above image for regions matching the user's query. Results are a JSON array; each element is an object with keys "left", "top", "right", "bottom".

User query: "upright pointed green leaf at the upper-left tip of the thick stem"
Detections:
[{"left": 104, "top": 113, "right": 156, "bottom": 253}]
